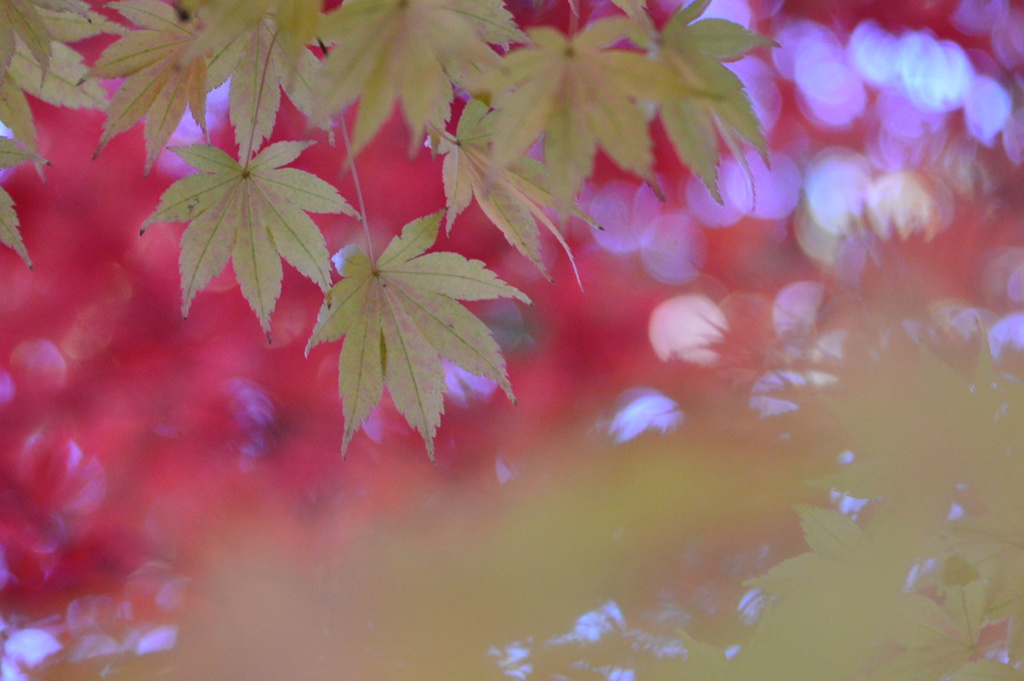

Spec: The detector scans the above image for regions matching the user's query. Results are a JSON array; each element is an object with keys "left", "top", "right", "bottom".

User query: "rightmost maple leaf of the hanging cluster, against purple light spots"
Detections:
[{"left": 658, "top": 0, "right": 777, "bottom": 203}]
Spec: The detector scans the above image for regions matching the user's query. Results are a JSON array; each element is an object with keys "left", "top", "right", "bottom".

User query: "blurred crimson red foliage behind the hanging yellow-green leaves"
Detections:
[{"left": 0, "top": 0, "right": 1022, "bottom": 675}]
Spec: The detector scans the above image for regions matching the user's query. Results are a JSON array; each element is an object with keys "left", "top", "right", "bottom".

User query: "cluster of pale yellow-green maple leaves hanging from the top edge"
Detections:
[{"left": 0, "top": 0, "right": 772, "bottom": 450}]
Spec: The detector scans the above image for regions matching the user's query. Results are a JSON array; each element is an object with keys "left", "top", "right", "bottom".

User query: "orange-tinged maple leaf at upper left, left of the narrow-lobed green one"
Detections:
[{"left": 88, "top": 0, "right": 216, "bottom": 172}]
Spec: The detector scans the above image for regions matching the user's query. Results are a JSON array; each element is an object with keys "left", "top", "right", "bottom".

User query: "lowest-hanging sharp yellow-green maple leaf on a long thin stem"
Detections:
[{"left": 306, "top": 211, "right": 529, "bottom": 459}]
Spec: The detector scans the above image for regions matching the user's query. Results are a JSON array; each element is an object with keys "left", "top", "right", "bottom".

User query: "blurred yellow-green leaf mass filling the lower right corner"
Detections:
[{"left": 671, "top": 352, "right": 1024, "bottom": 681}]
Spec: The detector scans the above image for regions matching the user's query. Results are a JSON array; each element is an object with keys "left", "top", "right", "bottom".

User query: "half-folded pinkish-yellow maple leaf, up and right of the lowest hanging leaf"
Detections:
[{"left": 438, "top": 99, "right": 592, "bottom": 276}]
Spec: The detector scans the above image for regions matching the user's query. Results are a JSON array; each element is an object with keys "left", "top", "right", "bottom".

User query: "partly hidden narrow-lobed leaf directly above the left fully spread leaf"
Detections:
[{"left": 228, "top": 20, "right": 319, "bottom": 159}]
